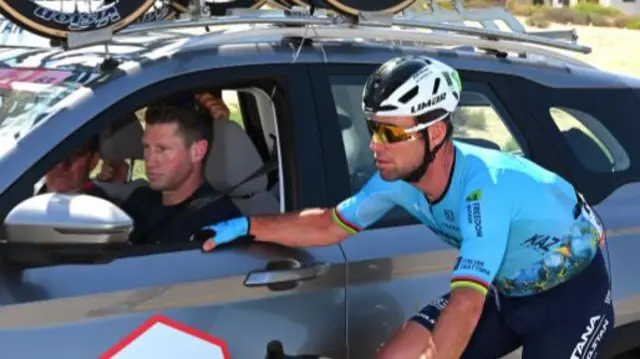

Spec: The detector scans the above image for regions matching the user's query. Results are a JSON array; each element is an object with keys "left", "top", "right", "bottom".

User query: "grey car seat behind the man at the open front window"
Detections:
[{"left": 205, "top": 120, "right": 280, "bottom": 215}]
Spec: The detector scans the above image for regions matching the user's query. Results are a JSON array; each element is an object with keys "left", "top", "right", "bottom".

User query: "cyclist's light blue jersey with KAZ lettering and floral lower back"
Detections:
[{"left": 334, "top": 141, "right": 604, "bottom": 296}]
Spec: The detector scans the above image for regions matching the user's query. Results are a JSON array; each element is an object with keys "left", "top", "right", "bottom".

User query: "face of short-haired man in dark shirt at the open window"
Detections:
[{"left": 142, "top": 123, "right": 206, "bottom": 191}]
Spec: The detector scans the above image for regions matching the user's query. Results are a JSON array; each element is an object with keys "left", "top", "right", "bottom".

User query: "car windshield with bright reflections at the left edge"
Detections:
[{"left": 0, "top": 67, "right": 93, "bottom": 147}]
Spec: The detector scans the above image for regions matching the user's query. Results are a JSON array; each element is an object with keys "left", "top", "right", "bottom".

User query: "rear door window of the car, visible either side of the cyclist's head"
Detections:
[{"left": 331, "top": 75, "right": 523, "bottom": 200}]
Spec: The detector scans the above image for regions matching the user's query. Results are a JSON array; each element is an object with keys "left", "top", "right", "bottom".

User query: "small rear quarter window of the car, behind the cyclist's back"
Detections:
[{"left": 549, "top": 107, "right": 630, "bottom": 173}]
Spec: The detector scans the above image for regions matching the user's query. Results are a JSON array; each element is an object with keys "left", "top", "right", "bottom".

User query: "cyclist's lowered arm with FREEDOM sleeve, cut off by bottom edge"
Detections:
[{"left": 433, "top": 179, "right": 512, "bottom": 359}]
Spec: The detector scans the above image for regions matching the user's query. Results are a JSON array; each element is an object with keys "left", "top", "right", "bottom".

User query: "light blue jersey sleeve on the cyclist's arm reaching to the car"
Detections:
[{"left": 332, "top": 172, "right": 408, "bottom": 234}]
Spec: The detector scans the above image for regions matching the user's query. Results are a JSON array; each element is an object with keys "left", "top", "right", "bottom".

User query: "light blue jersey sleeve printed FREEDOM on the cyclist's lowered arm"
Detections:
[{"left": 451, "top": 178, "right": 515, "bottom": 294}]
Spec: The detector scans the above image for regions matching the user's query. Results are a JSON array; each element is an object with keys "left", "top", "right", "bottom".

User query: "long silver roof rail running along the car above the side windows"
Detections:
[{"left": 180, "top": 26, "right": 593, "bottom": 68}]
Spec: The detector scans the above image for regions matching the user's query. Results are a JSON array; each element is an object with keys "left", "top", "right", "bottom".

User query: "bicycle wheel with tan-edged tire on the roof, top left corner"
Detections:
[{"left": 0, "top": 0, "right": 156, "bottom": 40}]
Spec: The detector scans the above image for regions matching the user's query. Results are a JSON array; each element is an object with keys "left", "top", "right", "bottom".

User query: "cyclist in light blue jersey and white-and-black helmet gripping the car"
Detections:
[{"left": 196, "top": 56, "right": 614, "bottom": 359}]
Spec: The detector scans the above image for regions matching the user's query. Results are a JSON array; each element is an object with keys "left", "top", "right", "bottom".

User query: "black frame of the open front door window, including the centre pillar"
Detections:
[{"left": 0, "top": 63, "right": 326, "bottom": 259}]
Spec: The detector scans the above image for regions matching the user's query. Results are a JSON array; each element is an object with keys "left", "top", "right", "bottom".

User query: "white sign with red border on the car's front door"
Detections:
[{"left": 100, "top": 315, "right": 231, "bottom": 359}]
